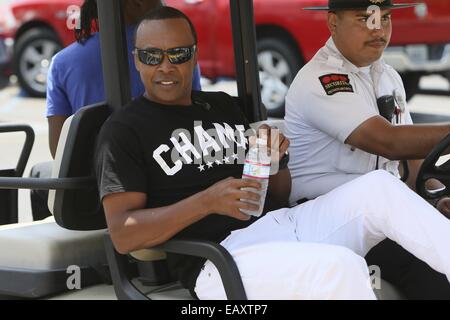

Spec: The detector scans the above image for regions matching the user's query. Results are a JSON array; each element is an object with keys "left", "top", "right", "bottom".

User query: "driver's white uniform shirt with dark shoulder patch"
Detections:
[{"left": 285, "top": 38, "right": 412, "bottom": 203}]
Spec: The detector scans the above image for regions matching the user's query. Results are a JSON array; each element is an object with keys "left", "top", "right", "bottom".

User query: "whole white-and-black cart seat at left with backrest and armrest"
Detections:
[{"left": 0, "top": 104, "right": 109, "bottom": 298}]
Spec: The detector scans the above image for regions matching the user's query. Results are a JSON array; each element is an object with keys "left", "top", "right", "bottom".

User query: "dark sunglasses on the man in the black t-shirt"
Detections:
[{"left": 133, "top": 44, "right": 197, "bottom": 66}]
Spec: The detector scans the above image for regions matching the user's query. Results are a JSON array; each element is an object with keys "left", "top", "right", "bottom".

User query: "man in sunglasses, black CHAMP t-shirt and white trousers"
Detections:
[{"left": 97, "top": 7, "right": 450, "bottom": 299}]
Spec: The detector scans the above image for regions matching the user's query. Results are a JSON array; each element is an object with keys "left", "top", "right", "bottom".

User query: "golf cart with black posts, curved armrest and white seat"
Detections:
[{"left": 0, "top": 0, "right": 450, "bottom": 300}]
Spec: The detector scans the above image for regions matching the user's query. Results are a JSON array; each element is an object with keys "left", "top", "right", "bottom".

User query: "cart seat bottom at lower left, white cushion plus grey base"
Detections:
[{"left": 0, "top": 217, "right": 106, "bottom": 298}]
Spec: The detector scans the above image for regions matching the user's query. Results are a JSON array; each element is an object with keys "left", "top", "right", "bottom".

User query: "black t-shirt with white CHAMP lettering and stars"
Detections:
[{"left": 96, "top": 92, "right": 254, "bottom": 291}]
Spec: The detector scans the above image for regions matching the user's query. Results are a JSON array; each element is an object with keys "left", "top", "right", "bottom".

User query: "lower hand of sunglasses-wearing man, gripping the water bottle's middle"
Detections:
[{"left": 202, "top": 178, "right": 261, "bottom": 220}]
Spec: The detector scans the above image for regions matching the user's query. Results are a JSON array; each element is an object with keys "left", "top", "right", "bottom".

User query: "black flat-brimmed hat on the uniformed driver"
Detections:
[{"left": 303, "top": 0, "right": 418, "bottom": 11}]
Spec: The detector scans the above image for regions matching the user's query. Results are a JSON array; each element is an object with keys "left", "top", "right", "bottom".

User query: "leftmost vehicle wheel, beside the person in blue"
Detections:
[{"left": 14, "top": 28, "right": 62, "bottom": 97}]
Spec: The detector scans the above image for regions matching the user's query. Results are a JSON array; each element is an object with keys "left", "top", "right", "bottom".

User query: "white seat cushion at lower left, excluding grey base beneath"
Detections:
[{"left": 0, "top": 217, "right": 106, "bottom": 271}]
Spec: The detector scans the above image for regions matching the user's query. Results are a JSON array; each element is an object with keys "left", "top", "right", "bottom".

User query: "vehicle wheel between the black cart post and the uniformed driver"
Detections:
[{"left": 257, "top": 38, "right": 303, "bottom": 117}]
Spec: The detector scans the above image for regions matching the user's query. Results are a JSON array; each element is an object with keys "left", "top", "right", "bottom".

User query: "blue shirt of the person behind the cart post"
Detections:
[{"left": 46, "top": 26, "right": 201, "bottom": 117}]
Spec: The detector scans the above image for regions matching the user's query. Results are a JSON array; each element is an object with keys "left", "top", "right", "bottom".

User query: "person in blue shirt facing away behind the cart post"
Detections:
[{"left": 30, "top": 0, "right": 201, "bottom": 220}]
